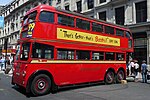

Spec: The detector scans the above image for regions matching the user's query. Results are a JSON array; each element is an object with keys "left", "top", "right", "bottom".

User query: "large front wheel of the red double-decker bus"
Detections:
[{"left": 31, "top": 74, "right": 51, "bottom": 96}]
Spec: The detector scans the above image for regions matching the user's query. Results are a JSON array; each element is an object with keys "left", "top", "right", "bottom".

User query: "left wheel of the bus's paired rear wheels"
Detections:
[{"left": 104, "top": 71, "right": 115, "bottom": 84}]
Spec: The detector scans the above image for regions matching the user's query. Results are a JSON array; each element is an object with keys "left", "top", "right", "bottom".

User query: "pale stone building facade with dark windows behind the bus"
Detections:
[{"left": 0, "top": 0, "right": 150, "bottom": 64}]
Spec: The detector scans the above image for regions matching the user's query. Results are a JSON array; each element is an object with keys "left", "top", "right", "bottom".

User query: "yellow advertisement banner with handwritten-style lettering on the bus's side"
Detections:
[{"left": 57, "top": 28, "right": 120, "bottom": 46}]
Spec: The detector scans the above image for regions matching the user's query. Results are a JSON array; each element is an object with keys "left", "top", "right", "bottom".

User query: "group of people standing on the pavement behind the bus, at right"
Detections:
[{"left": 127, "top": 60, "right": 148, "bottom": 83}]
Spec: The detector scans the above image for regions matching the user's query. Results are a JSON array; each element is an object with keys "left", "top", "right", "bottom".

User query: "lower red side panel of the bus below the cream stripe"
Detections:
[{"left": 22, "top": 64, "right": 125, "bottom": 86}]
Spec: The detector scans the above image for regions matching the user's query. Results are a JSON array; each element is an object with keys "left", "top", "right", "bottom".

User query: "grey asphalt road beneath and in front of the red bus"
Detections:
[{"left": 0, "top": 73, "right": 150, "bottom": 100}]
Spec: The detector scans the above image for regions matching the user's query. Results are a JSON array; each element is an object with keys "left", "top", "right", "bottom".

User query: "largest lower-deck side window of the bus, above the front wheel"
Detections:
[{"left": 31, "top": 43, "right": 54, "bottom": 59}]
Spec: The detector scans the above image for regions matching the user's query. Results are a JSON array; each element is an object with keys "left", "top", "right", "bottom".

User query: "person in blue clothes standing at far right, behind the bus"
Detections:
[{"left": 141, "top": 60, "right": 148, "bottom": 83}]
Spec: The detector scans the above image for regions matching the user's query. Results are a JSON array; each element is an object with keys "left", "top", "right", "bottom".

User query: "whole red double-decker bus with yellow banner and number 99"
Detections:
[{"left": 12, "top": 5, "right": 133, "bottom": 95}]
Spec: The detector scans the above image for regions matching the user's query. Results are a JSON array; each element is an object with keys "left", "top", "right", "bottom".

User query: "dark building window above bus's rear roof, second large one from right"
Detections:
[{"left": 115, "top": 7, "right": 125, "bottom": 25}]
